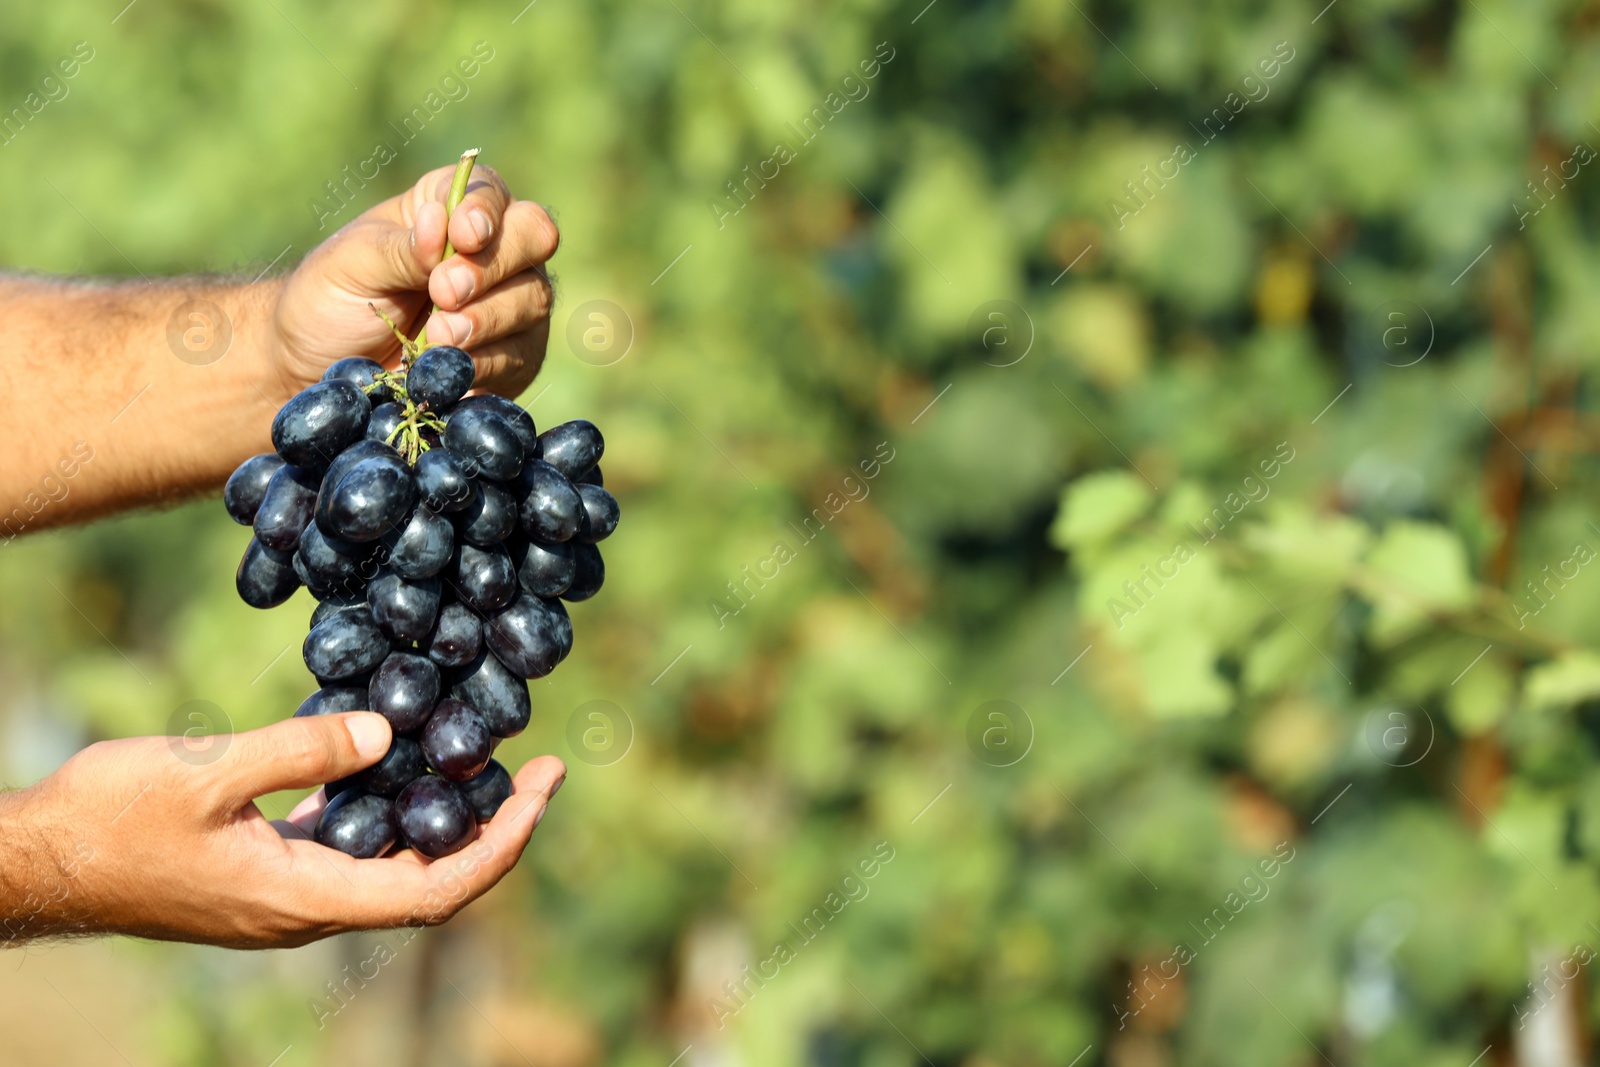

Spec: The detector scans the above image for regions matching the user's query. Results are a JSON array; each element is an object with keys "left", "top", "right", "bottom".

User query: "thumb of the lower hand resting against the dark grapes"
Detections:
[{"left": 211, "top": 712, "right": 392, "bottom": 805}]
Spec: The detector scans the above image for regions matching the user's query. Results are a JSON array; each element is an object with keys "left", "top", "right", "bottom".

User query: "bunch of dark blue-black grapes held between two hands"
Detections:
[{"left": 222, "top": 346, "right": 618, "bottom": 857}]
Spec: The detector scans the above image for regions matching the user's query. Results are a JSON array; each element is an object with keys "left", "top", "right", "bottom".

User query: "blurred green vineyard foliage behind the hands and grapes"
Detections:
[{"left": 0, "top": 0, "right": 1600, "bottom": 1067}]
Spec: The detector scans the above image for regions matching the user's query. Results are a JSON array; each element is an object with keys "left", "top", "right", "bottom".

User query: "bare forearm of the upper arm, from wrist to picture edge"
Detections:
[{"left": 0, "top": 278, "right": 286, "bottom": 527}]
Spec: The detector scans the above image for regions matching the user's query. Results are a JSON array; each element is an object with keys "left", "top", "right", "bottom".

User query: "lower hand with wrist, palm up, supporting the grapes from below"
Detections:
[{"left": 0, "top": 712, "right": 566, "bottom": 949}]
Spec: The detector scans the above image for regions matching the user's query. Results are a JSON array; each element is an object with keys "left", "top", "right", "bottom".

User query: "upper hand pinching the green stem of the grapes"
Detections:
[{"left": 272, "top": 166, "right": 560, "bottom": 400}]
